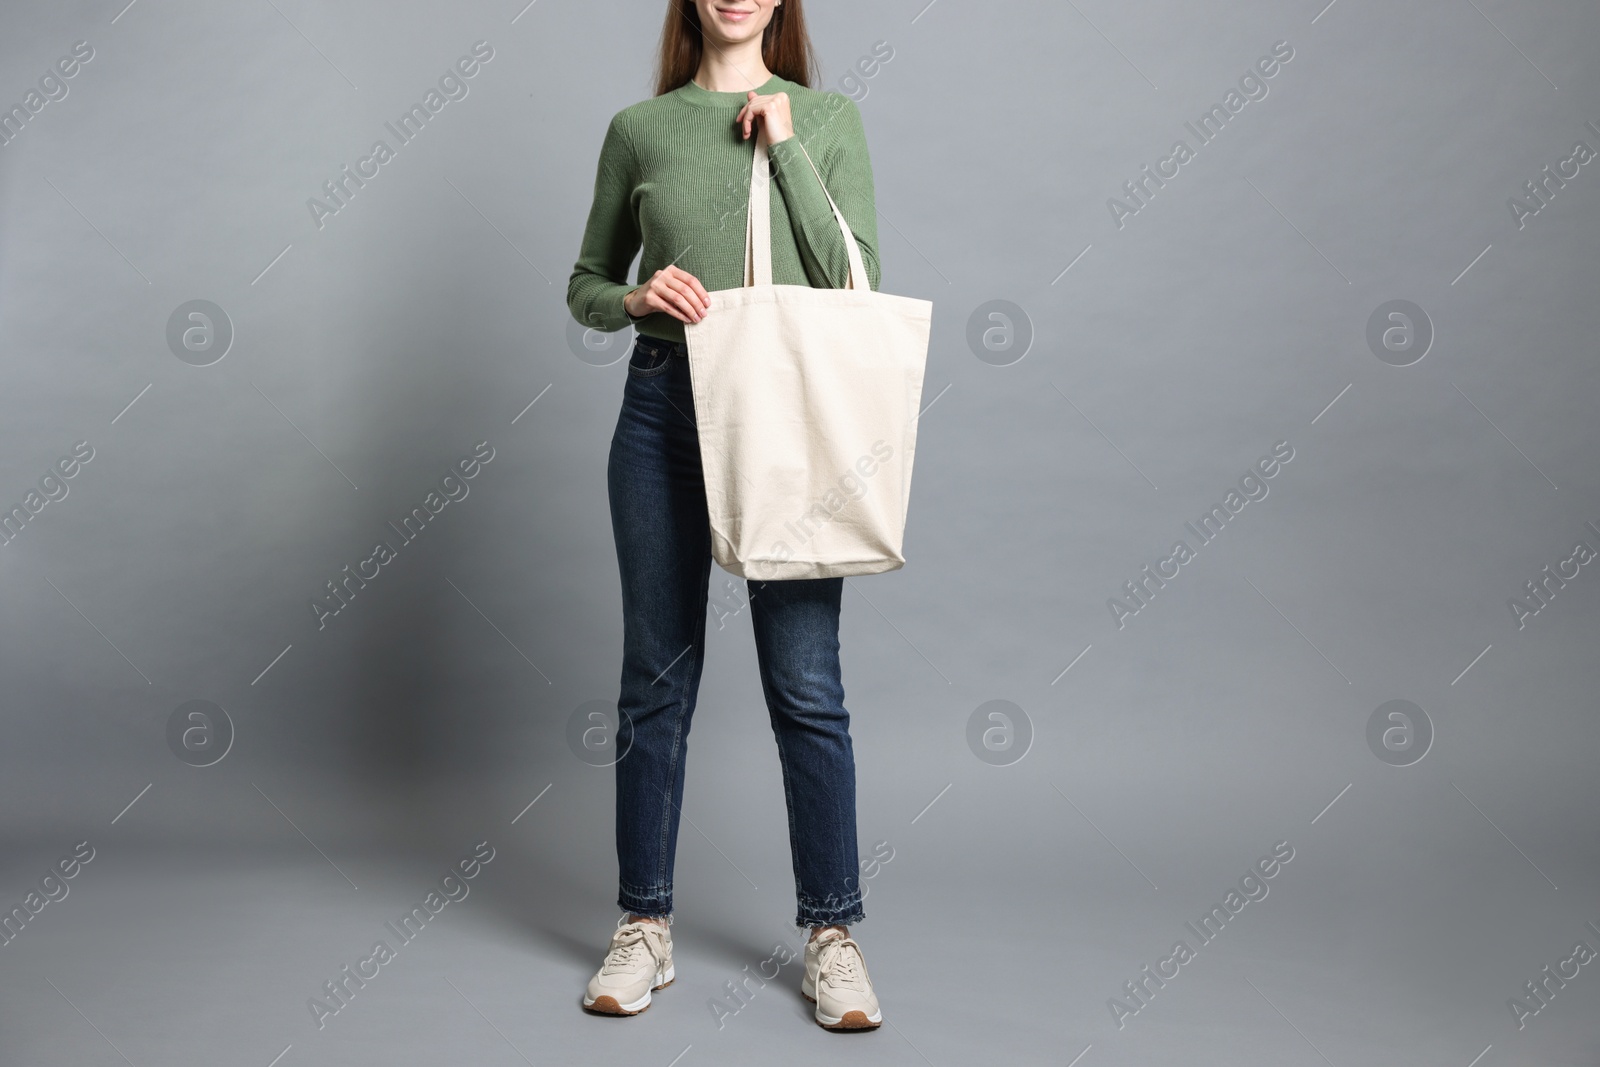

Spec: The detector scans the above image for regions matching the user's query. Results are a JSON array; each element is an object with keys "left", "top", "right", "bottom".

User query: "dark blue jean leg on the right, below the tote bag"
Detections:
[{"left": 747, "top": 577, "right": 864, "bottom": 926}]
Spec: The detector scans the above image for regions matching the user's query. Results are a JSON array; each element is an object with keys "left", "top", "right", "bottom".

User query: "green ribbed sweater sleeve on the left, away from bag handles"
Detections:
[{"left": 566, "top": 112, "right": 636, "bottom": 331}]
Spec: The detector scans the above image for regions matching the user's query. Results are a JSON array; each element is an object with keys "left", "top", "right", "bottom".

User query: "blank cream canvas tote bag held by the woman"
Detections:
[{"left": 683, "top": 130, "right": 933, "bottom": 581}]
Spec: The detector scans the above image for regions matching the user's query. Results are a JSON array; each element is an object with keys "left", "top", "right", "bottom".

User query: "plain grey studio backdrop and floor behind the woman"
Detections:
[{"left": 0, "top": 0, "right": 1600, "bottom": 1067}]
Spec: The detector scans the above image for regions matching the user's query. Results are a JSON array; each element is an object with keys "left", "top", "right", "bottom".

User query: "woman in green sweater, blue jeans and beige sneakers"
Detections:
[{"left": 566, "top": 0, "right": 883, "bottom": 1030}]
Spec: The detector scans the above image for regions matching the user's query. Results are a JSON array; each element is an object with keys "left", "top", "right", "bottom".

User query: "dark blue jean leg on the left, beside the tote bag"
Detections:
[{"left": 606, "top": 338, "right": 712, "bottom": 917}]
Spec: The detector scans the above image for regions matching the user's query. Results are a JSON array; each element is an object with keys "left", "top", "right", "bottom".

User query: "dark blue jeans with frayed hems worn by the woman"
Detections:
[{"left": 606, "top": 334, "right": 862, "bottom": 926}]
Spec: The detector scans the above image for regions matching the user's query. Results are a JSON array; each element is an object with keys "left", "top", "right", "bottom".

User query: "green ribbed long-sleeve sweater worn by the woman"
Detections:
[{"left": 566, "top": 75, "right": 878, "bottom": 341}]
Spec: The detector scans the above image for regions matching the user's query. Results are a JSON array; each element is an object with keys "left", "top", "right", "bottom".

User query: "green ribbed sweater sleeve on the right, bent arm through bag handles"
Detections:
[{"left": 768, "top": 93, "right": 878, "bottom": 290}]
